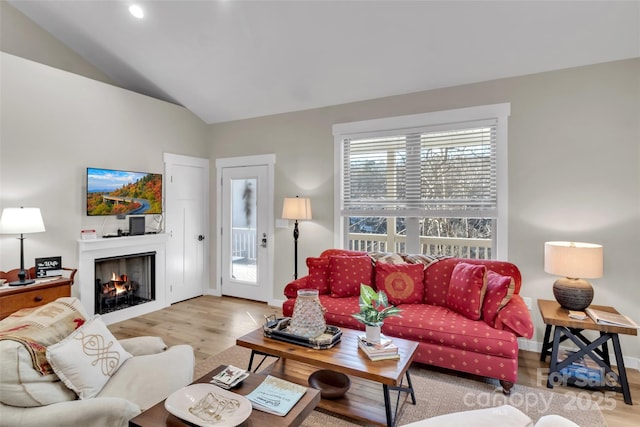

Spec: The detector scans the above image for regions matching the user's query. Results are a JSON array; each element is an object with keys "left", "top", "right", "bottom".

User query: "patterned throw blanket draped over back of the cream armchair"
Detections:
[{"left": 0, "top": 298, "right": 85, "bottom": 375}]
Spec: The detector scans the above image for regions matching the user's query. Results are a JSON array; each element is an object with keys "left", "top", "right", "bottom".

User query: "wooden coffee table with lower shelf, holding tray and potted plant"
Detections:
[{"left": 236, "top": 328, "right": 418, "bottom": 427}]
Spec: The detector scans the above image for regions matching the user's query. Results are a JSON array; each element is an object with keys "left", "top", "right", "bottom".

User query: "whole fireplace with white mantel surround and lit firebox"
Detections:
[{"left": 78, "top": 234, "right": 168, "bottom": 325}]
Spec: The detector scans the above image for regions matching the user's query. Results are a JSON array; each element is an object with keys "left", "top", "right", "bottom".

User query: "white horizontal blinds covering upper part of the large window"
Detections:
[{"left": 342, "top": 119, "right": 497, "bottom": 217}]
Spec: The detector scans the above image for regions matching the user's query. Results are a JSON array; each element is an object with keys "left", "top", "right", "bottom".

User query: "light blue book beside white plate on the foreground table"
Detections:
[{"left": 245, "top": 375, "right": 307, "bottom": 417}]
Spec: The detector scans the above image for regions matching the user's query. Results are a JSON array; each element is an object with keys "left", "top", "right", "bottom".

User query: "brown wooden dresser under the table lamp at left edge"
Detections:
[{"left": 0, "top": 271, "right": 75, "bottom": 319}]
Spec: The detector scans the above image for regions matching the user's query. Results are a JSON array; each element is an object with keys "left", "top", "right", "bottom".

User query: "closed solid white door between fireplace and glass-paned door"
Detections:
[{"left": 165, "top": 154, "right": 209, "bottom": 303}]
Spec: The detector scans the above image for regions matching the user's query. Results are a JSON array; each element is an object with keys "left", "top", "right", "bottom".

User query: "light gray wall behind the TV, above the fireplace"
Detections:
[{"left": 0, "top": 52, "right": 208, "bottom": 280}]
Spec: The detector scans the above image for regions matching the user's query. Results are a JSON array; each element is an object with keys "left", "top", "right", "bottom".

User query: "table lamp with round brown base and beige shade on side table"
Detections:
[{"left": 544, "top": 242, "right": 603, "bottom": 310}]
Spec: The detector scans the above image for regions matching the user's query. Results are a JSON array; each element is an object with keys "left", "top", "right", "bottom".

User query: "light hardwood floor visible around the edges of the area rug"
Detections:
[{"left": 109, "top": 296, "right": 640, "bottom": 427}]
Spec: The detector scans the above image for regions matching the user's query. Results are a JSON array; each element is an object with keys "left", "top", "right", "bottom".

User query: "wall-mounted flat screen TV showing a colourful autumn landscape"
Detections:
[{"left": 87, "top": 168, "right": 162, "bottom": 216}]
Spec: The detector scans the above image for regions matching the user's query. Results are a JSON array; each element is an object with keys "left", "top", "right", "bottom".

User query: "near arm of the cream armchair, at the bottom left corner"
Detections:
[{"left": 0, "top": 397, "right": 141, "bottom": 427}]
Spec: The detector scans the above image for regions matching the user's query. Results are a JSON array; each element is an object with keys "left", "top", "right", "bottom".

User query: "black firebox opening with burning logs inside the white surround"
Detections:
[{"left": 95, "top": 252, "right": 156, "bottom": 314}]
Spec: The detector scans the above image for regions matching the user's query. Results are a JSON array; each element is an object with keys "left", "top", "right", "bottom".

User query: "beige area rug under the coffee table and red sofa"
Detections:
[{"left": 195, "top": 346, "right": 607, "bottom": 427}]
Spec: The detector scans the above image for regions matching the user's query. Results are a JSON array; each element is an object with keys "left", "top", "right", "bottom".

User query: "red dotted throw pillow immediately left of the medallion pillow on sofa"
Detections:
[{"left": 329, "top": 255, "right": 373, "bottom": 298}]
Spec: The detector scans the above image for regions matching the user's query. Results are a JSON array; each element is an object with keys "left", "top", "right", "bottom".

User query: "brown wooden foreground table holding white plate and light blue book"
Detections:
[{"left": 129, "top": 365, "right": 320, "bottom": 427}]
